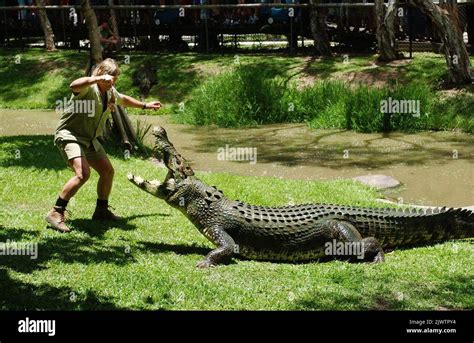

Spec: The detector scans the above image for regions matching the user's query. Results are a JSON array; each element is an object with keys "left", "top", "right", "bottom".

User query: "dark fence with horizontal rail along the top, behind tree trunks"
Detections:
[{"left": 0, "top": 0, "right": 474, "bottom": 53}]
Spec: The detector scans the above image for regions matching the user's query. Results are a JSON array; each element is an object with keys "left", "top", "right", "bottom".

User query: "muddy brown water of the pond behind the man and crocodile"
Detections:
[{"left": 0, "top": 110, "right": 474, "bottom": 206}]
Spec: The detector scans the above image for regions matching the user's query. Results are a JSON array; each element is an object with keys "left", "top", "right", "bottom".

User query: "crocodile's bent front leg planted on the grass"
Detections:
[{"left": 196, "top": 226, "right": 237, "bottom": 268}]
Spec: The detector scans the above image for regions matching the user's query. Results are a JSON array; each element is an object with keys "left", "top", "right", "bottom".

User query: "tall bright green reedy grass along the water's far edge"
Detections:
[{"left": 176, "top": 65, "right": 474, "bottom": 132}]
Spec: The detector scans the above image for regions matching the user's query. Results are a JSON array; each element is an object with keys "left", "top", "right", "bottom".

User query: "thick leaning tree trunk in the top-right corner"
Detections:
[{"left": 410, "top": 0, "right": 472, "bottom": 85}]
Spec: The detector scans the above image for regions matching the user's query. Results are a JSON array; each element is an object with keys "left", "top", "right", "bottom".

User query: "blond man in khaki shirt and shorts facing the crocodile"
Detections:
[{"left": 46, "top": 58, "right": 161, "bottom": 232}]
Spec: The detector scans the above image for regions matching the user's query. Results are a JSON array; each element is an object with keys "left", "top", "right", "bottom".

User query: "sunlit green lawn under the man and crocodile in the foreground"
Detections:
[{"left": 0, "top": 136, "right": 474, "bottom": 310}]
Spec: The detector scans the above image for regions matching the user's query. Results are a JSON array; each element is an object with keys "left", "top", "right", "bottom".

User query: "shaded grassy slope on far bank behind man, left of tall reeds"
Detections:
[{"left": 0, "top": 49, "right": 302, "bottom": 113}]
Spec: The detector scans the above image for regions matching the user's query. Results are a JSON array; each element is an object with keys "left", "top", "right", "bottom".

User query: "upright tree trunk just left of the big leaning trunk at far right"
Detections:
[{"left": 375, "top": 0, "right": 400, "bottom": 61}]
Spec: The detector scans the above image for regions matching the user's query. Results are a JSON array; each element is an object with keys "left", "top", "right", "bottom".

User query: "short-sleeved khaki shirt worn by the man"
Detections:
[{"left": 54, "top": 84, "right": 124, "bottom": 151}]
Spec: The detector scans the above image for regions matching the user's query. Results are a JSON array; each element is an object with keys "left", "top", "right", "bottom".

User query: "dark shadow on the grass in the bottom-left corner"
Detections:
[{"left": 0, "top": 267, "right": 122, "bottom": 311}]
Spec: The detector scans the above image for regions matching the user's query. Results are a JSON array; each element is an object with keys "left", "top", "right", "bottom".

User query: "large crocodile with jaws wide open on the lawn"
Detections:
[{"left": 128, "top": 127, "right": 474, "bottom": 268}]
